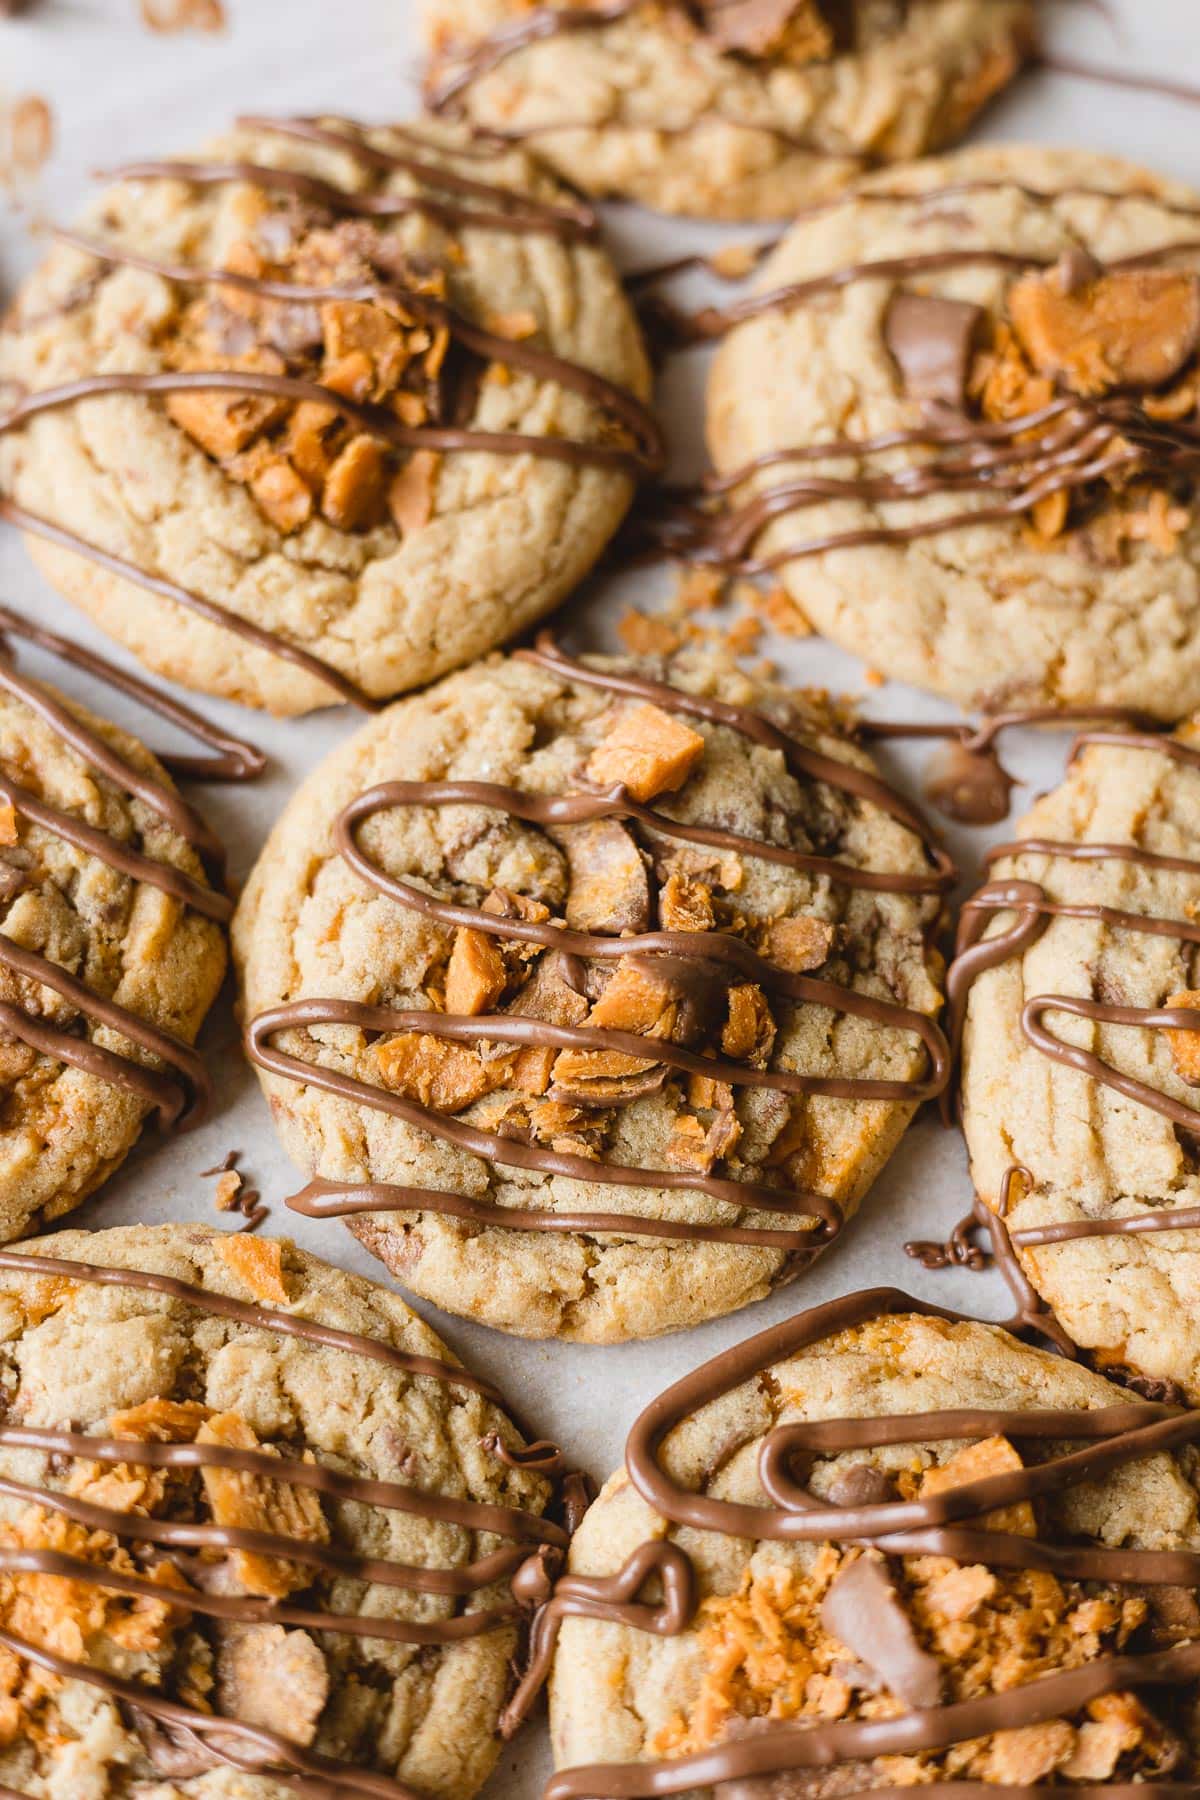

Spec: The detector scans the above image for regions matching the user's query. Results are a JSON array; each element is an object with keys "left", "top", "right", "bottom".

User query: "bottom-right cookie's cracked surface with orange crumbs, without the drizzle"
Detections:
[{"left": 551, "top": 1291, "right": 1200, "bottom": 1800}]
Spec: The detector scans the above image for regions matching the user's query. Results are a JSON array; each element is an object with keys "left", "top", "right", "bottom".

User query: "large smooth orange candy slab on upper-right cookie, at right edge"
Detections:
[{"left": 1007, "top": 268, "right": 1200, "bottom": 394}]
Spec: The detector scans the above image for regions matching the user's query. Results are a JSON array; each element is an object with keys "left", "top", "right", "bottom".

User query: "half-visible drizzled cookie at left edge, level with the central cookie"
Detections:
[{"left": 0, "top": 608, "right": 232, "bottom": 1242}]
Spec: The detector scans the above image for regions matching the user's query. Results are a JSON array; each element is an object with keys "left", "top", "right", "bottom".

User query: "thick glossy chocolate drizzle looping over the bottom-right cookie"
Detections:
[{"left": 534, "top": 1289, "right": 1200, "bottom": 1800}]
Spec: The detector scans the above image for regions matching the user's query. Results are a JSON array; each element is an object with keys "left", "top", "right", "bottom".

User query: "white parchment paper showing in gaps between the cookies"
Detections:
[{"left": 0, "top": 0, "right": 1200, "bottom": 1800}]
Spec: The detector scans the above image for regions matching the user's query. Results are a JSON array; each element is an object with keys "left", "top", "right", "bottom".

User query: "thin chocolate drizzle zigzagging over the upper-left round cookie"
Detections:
[{"left": 0, "top": 117, "right": 666, "bottom": 711}]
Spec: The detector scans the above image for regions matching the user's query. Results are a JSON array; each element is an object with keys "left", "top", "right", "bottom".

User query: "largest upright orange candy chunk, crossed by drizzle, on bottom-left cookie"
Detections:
[{"left": 196, "top": 1411, "right": 329, "bottom": 1600}]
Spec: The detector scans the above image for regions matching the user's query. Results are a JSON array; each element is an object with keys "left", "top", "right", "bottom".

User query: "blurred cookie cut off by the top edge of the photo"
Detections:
[{"left": 425, "top": 0, "right": 1034, "bottom": 220}]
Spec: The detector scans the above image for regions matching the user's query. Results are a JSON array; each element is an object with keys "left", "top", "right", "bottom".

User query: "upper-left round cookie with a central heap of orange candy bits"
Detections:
[{"left": 0, "top": 108, "right": 662, "bottom": 713}]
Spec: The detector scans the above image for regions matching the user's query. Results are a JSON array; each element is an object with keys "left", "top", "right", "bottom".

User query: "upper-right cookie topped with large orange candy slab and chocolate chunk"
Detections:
[{"left": 708, "top": 148, "right": 1200, "bottom": 720}]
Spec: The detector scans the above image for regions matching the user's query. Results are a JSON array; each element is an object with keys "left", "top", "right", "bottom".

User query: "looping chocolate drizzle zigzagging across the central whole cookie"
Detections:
[{"left": 246, "top": 637, "right": 954, "bottom": 1267}]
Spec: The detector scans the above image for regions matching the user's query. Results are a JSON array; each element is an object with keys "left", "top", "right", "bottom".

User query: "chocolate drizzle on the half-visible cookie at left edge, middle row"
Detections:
[{"left": 0, "top": 607, "right": 251, "bottom": 1130}]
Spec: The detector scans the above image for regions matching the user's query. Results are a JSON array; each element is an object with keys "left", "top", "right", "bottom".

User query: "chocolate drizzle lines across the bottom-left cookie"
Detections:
[{"left": 0, "top": 1251, "right": 569, "bottom": 1800}]
